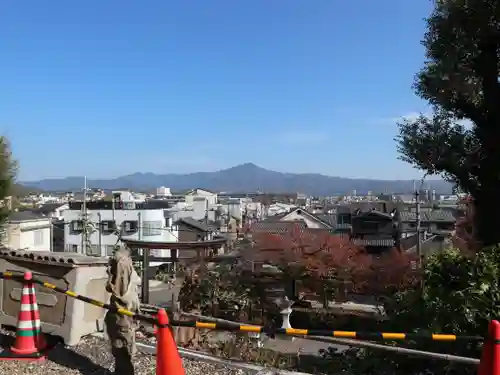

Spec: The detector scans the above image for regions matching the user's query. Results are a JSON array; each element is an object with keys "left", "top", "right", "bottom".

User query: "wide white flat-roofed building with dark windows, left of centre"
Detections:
[{"left": 63, "top": 200, "right": 179, "bottom": 266}]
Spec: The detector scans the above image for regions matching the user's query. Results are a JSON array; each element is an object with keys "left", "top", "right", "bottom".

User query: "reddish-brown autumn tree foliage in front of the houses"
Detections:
[{"left": 247, "top": 225, "right": 417, "bottom": 300}]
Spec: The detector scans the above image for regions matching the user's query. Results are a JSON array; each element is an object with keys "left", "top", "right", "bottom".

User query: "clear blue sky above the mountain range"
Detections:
[{"left": 0, "top": 0, "right": 431, "bottom": 180}]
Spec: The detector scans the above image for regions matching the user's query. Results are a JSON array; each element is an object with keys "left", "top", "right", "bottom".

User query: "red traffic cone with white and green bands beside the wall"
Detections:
[{"left": 0, "top": 272, "right": 47, "bottom": 361}]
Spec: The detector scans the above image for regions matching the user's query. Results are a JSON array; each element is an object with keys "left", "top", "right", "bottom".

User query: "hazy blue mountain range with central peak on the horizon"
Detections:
[{"left": 22, "top": 163, "right": 451, "bottom": 196}]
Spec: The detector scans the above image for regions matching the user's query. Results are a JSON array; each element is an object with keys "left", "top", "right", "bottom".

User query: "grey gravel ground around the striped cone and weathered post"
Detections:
[{"left": 0, "top": 330, "right": 250, "bottom": 375}]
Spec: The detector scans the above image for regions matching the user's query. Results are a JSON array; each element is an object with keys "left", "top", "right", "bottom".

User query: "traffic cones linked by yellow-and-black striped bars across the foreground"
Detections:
[{"left": 0, "top": 272, "right": 500, "bottom": 375}]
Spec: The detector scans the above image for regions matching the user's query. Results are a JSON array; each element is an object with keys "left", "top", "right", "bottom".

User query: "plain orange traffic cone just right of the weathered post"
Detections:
[{"left": 156, "top": 309, "right": 185, "bottom": 375}]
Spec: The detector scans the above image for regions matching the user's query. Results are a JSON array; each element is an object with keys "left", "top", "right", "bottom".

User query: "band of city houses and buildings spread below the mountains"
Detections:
[{"left": 1, "top": 180, "right": 463, "bottom": 264}]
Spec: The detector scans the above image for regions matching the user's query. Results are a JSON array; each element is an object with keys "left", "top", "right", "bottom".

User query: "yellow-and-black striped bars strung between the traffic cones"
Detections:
[{"left": 0, "top": 272, "right": 484, "bottom": 341}]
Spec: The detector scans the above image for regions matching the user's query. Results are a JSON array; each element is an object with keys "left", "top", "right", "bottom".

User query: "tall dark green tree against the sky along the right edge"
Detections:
[{"left": 396, "top": 0, "right": 500, "bottom": 246}]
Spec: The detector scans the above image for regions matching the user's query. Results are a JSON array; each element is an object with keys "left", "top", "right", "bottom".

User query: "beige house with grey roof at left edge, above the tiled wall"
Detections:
[{"left": 2, "top": 211, "right": 52, "bottom": 251}]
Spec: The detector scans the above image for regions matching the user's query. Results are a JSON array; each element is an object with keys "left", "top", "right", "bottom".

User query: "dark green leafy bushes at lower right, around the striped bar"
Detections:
[{"left": 330, "top": 248, "right": 500, "bottom": 375}]
